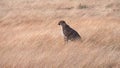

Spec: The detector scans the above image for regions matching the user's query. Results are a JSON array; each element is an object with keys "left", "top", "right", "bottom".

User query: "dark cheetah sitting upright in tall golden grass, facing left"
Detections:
[{"left": 58, "top": 20, "right": 81, "bottom": 42}]
